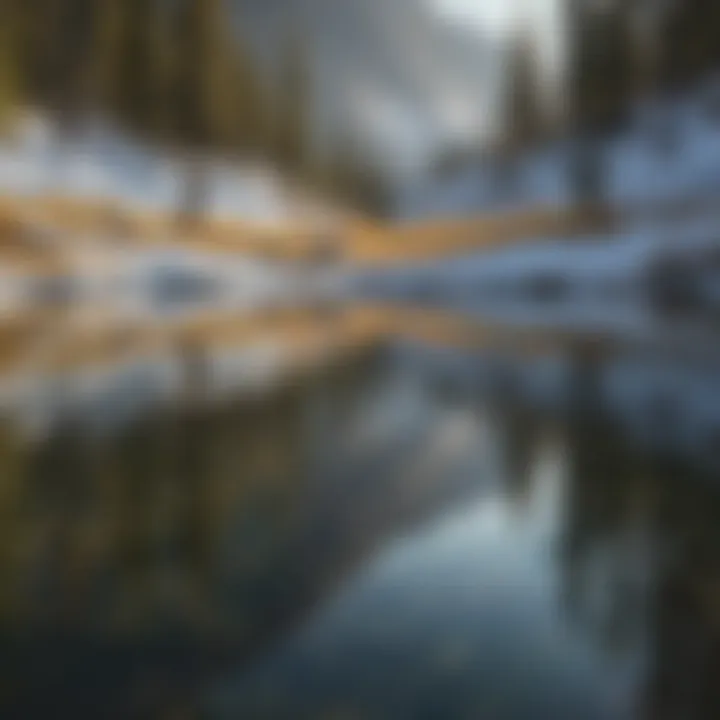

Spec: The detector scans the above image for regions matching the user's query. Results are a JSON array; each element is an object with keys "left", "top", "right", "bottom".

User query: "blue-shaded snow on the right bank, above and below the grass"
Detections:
[{"left": 366, "top": 79, "right": 720, "bottom": 334}]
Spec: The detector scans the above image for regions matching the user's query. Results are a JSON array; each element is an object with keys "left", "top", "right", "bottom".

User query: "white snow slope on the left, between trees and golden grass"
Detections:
[{"left": 0, "top": 115, "right": 330, "bottom": 224}]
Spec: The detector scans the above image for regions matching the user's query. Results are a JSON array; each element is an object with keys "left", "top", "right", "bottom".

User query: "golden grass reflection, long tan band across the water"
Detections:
[{"left": 0, "top": 306, "right": 600, "bottom": 386}]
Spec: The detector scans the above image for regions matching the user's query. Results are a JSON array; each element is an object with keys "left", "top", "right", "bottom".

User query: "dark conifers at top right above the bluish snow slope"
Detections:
[{"left": 438, "top": 0, "right": 720, "bottom": 207}]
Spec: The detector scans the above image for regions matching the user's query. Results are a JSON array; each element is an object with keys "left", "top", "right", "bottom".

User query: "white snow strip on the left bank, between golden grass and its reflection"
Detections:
[{"left": 0, "top": 249, "right": 348, "bottom": 323}]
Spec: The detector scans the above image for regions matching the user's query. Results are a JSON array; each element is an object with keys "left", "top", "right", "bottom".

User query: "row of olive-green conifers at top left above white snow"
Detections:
[{"left": 0, "top": 0, "right": 390, "bottom": 216}]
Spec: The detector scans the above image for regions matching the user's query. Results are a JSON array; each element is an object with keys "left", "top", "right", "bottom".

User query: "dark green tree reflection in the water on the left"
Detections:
[{"left": 0, "top": 346, "right": 388, "bottom": 717}]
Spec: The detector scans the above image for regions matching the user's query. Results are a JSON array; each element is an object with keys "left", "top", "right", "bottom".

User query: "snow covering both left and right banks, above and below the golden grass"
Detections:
[{"left": 0, "top": 84, "right": 720, "bottom": 328}]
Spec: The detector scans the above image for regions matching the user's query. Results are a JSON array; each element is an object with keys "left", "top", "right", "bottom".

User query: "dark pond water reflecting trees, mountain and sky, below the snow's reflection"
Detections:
[{"left": 0, "top": 328, "right": 720, "bottom": 720}]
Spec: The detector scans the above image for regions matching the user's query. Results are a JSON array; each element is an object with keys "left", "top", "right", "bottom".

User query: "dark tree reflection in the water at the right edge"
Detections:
[{"left": 561, "top": 338, "right": 720, "bottom": 720}]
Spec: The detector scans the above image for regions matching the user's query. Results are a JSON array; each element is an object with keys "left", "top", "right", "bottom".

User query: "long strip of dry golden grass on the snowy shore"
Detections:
[{"left": 0, "top": 191, "right": 610, "bottom": 276}]
